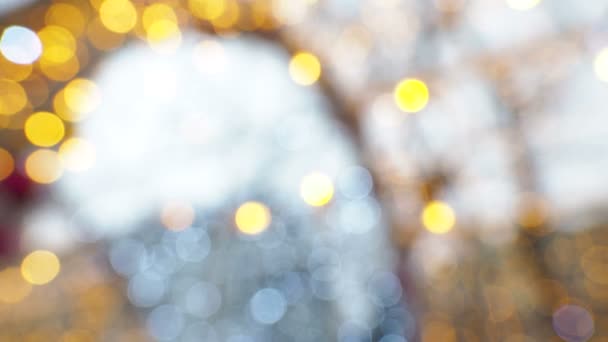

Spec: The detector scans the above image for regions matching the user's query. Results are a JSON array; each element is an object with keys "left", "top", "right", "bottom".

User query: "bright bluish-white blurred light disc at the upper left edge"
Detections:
[{"left": 0, "top": 26, "right": 42, "bottom": 64}]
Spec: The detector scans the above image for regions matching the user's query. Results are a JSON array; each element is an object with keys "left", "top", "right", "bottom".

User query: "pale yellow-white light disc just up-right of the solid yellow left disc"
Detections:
[{"left": 63, "top": 78, "right": 101, "bottom": 121}]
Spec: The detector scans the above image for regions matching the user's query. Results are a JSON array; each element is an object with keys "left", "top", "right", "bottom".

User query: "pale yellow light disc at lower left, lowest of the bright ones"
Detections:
[{"left": 21, "top": 250, "right": 61, "bottom": 285}]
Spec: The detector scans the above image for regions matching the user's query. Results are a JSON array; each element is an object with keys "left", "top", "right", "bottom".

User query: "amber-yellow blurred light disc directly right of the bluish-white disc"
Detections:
[{"left": 38, "top": 25, "right": 76, "bottom": 63}]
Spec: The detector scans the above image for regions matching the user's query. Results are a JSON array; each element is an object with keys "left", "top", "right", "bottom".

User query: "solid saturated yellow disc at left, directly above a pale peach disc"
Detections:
[{"left": 24, "top": 112, "right": 65, "bottom": 147}]
